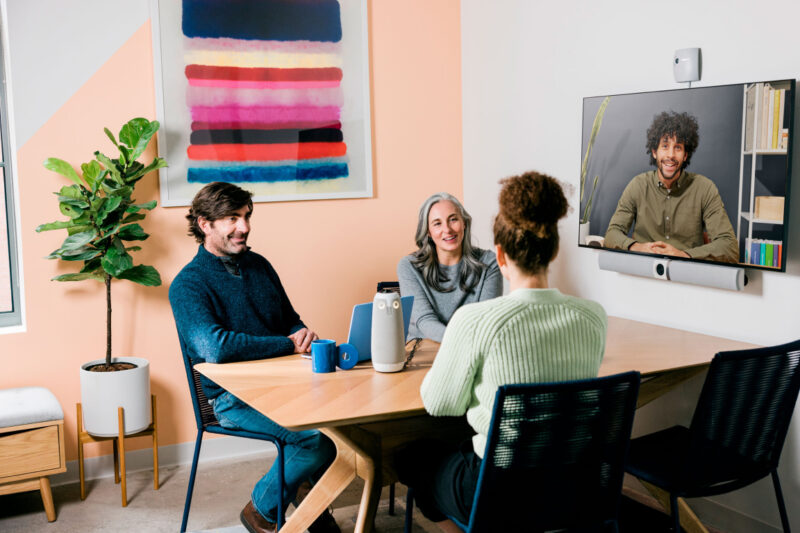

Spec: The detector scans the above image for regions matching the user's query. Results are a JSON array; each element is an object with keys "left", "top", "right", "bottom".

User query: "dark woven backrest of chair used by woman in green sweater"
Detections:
[{"left": 469, "top": 372, "right": 640, "bottom": 532}]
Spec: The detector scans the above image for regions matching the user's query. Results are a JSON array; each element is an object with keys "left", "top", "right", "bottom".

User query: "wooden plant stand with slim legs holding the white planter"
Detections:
[{"left": 76, "top": 394, "right": 158, "bottom": 507}]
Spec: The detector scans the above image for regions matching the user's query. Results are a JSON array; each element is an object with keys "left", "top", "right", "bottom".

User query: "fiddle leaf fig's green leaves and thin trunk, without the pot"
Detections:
[{"left": 36, "top": 118, "right": 167, "bottom": 371}]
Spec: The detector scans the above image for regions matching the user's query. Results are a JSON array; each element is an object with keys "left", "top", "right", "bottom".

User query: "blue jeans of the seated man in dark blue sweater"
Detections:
[{"left": 214, "top": 392, "right": 336, "bottom": 522}]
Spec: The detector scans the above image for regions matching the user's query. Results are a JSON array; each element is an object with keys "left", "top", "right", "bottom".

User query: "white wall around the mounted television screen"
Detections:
[{"left": 461, "top": 0, "right": 800, "bottom": 531}]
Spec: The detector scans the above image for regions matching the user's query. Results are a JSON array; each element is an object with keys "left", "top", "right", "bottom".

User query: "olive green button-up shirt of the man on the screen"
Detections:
[{"left": 605, "top": 170, "right": 739, "bottom": 263}]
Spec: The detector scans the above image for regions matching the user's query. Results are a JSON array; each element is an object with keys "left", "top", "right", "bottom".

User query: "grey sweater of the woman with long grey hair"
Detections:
[{"left": 397, "top": 249, "right": 503, "bottom": 342}]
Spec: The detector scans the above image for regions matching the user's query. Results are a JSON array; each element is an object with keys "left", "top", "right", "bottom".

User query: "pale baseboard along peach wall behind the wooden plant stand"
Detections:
[{"left": 50, "top": 436, "right": 278, "bottom": 486}]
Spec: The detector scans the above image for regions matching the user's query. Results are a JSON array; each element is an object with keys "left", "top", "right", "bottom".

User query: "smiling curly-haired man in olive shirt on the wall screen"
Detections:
[{"left": 605, "top": 111, "right": 739, "bottom": 263}]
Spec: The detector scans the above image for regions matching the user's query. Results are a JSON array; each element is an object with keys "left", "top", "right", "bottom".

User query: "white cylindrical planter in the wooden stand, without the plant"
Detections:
[{"left": 81, "top": 357, "right": 152, "bottom": 437}]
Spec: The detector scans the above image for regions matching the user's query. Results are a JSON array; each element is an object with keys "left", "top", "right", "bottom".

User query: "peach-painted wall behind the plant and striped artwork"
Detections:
[{"left": 0, "top": 0, "right": 462, "bottom": 459}]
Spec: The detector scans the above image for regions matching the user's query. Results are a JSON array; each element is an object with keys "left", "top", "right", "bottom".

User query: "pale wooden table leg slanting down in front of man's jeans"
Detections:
[{"left": 280, "top": 429, "right": 356, "bottom": 533}]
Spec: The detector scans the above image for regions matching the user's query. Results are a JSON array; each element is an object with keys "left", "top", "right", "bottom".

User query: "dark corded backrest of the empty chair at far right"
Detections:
[{"left": 685, "top": 341, "right": 800, "bottom": 492}]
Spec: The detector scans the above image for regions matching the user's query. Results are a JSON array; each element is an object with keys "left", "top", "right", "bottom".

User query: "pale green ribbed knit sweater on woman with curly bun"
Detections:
[{"left": 420, "top": 289, "right": 607, "bottom": 457}]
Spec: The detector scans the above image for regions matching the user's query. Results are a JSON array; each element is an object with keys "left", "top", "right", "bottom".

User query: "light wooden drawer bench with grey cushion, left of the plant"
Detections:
[{"left": 0, "top": 387, "right": 67, "bottom": 522}]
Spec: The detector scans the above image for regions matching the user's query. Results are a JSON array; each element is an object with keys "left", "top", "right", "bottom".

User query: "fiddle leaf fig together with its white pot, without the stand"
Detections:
[{"left": 36, "top": 118, "right": 166, "bottom": 436}]
